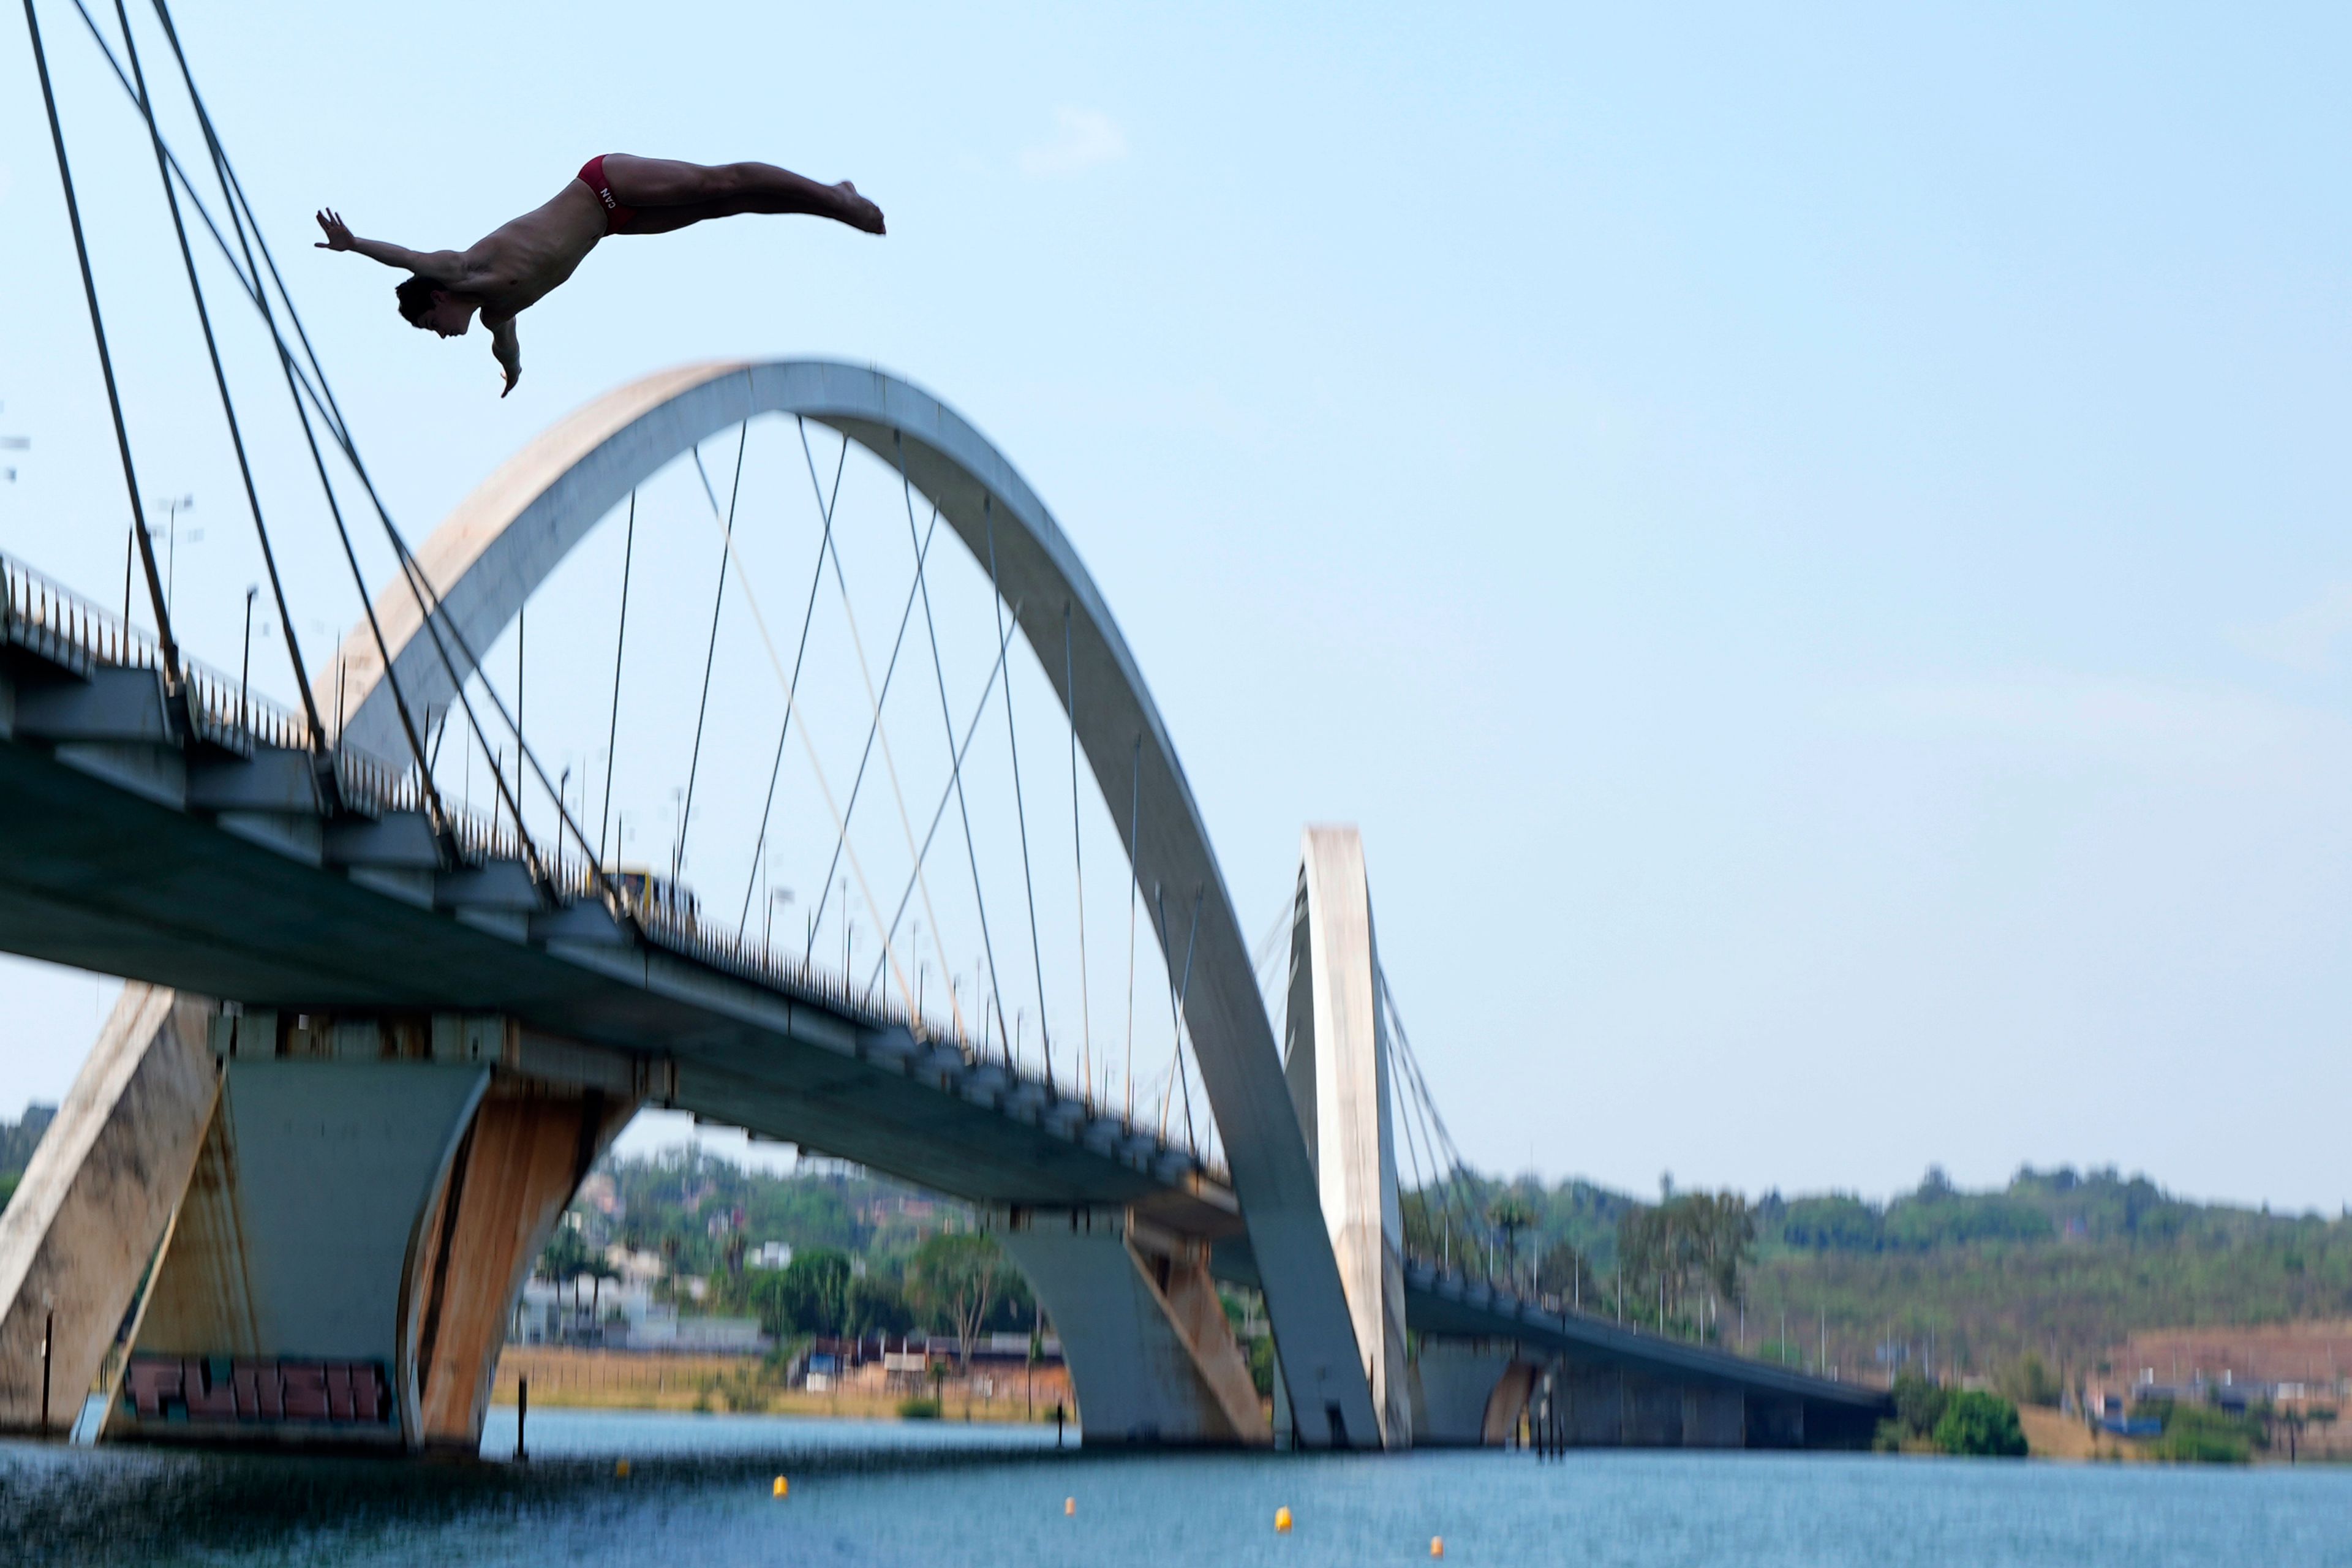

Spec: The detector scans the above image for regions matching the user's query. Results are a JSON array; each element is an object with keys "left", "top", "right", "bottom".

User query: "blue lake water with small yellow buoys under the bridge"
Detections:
[{"left": 0, "top": 1411, "right": 2352, "bottom": 1568}]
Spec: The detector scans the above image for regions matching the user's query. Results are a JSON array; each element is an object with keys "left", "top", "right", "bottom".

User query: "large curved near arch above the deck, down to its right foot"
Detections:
[{"left": 341, "top": 360, "right": 1383, "bottom": 1446}]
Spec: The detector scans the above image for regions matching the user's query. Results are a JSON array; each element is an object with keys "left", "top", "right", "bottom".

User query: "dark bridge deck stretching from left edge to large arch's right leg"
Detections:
[{"left": 0, "top": 623, "right": 1237, "bottom": 1237}]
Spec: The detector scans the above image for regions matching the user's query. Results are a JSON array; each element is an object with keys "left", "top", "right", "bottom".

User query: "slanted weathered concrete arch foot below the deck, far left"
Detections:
[{"left": 0, "top": 980, "right": 219, "bottom": 1431}]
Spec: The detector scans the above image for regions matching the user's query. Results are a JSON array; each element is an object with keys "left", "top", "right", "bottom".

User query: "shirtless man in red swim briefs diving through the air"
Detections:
[{"left": 317, "top": 153, "right": 882, "bottom": 398}]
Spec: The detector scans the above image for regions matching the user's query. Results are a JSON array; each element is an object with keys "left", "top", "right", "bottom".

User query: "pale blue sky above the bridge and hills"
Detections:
[{"left": 0, "top": 0, "right": 2352, "bottom": 1211}]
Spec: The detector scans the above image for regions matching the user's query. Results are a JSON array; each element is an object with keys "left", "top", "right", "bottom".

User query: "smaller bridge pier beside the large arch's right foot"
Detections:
[{"left": 997, "top": 1208, "right": 1272, "bottom": 1446}]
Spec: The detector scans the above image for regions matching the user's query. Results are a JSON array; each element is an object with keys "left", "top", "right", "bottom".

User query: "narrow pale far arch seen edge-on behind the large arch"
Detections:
[{"left": 1284, "top": 827, "right": 1414, "bottom": 1448}]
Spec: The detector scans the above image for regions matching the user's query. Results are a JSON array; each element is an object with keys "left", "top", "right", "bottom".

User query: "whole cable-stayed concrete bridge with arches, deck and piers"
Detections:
[{"left": 0, "top": 2, "right": 1884, "bottom": 1453}]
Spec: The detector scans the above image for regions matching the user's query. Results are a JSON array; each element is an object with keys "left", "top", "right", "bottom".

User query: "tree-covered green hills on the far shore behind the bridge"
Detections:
[{"left": 0, "top": 1105, "right": 2323, "bottom": 1382}]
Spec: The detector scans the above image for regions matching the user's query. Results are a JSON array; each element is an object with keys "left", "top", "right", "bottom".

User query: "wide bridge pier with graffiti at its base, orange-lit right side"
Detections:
[{"left": 90, "top": 1009, "right": 638, "bottom": 1453}]
